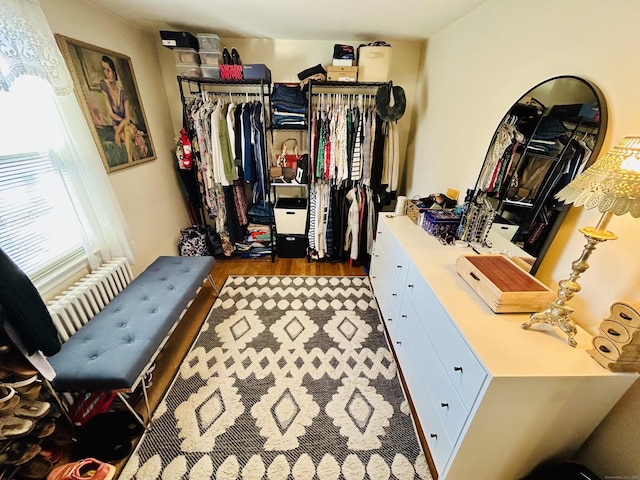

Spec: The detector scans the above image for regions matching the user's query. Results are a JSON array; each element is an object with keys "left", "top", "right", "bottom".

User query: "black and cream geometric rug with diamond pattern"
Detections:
[{"left": 119, "top": 276, "right": 431, "bottom": 480}]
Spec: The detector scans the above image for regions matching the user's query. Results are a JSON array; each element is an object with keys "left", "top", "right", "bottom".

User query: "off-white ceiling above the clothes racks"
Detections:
[{"left": 85, "top": 0, "right": 486, "bottom": 42}]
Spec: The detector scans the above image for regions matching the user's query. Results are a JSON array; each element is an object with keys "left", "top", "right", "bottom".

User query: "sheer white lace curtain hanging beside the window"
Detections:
[{"left": 0, "top": 0, "right": 135, "bottom": 268}]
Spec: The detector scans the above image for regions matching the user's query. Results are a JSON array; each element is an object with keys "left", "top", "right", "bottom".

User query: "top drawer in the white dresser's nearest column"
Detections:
[{"left": 406, "top": 265, "right": 487, "bottom": 411}]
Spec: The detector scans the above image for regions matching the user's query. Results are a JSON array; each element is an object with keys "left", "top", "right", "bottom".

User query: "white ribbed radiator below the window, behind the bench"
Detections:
[{"left": 47, "top": 258, "right": 133, "bottom": 343}]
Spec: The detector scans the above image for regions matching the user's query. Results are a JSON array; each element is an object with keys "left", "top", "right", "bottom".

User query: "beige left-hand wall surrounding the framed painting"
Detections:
[{"left": 41, "top": 0, "right": 190, "bottom": 274}]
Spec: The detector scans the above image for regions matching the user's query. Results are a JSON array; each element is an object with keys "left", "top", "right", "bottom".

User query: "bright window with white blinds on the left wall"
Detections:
[{"left": 0, "top": 76, "right": 93, "bottom": 286}]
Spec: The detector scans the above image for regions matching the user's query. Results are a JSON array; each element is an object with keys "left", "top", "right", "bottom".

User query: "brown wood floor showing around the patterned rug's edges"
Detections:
[{"left": 116, "top": 258, "right": 365, "bottom": 473}]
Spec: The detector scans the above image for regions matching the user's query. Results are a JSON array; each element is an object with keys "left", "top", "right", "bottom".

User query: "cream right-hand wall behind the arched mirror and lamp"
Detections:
[{"left": 407, "top": 0, "right": 640, "bottom": 478}]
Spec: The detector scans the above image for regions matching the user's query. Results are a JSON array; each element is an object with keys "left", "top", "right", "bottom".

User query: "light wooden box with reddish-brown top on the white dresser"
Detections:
[{"left": 456, "top": 255, "right": 556, "bottom": 313}]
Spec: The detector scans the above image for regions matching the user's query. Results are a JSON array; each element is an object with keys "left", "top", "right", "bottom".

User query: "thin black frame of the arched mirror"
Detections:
[{"left": 473, "top": 75, "right": 608, "bottom": 275}]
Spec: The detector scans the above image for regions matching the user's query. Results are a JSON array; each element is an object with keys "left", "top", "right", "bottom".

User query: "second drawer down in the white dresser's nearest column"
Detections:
[{"left": 400, "top": 302, "right": 468, "bottom": 444}]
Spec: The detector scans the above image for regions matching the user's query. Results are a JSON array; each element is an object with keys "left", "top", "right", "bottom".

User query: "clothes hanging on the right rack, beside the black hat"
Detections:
[{"left": 307, "top": 94, "right": 400, "bottom": 265}]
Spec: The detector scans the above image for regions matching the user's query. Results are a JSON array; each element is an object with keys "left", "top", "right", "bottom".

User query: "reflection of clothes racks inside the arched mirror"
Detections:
[{"left": 461, "top": 76, "right": 607, "bottom": 274}]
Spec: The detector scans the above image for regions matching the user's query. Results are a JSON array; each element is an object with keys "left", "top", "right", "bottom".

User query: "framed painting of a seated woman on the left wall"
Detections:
[{"left": 56, "top": 34, "right": 156, "bottom": 173}]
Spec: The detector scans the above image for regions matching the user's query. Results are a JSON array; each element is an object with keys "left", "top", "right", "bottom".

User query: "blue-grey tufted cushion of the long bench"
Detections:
[{"left": 49, "top": 257, "right": 215, "bottom": 392}]
